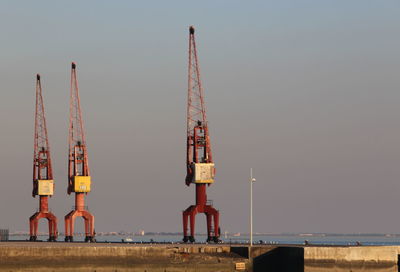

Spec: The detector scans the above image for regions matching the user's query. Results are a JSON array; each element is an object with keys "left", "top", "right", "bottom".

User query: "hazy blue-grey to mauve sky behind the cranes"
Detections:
[{"left": 0, "top": 0, "right": 400, "bottom": 233}]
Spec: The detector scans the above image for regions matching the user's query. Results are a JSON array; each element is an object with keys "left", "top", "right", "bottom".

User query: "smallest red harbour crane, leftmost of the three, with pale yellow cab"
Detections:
[{"left": 29, "top": 74, "right": 58, "bottom": 241}]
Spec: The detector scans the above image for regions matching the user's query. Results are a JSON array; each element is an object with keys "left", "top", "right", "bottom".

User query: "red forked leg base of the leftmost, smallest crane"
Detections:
[{"left": 29, "top": 196, "right": 58, "bottom": 242}]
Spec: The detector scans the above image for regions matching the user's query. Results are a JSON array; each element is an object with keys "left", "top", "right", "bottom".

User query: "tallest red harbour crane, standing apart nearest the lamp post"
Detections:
[{"left": 183, "top": 26, "right": 220, "bottom": 243}]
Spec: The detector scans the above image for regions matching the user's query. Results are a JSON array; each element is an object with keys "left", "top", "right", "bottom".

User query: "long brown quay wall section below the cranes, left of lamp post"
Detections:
[{"left": 0, "top": 242, "right": 251, "bottom": 272}]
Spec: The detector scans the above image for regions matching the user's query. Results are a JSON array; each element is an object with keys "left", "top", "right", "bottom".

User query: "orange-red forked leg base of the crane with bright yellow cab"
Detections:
[{"left": 65, "top": 193, "right": 95, "bottom": 242}]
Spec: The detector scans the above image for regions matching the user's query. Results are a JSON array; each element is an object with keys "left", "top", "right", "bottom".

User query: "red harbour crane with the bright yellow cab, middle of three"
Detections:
[{"left": 65, "top": 62, "right": 95, "bottom": 242}]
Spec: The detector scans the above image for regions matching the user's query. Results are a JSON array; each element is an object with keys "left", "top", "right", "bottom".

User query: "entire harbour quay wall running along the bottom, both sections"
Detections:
[{"left": 0, "top": 242, "right": 400, "bottom": 272}]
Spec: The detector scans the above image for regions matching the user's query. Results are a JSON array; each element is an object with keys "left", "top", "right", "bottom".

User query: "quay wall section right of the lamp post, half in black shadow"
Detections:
[{"left": 251, "top": 245, "right": 400, "bottom": 272}]
